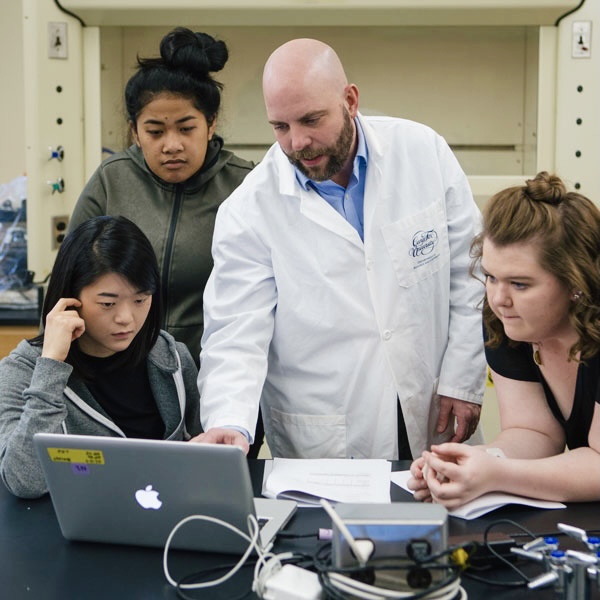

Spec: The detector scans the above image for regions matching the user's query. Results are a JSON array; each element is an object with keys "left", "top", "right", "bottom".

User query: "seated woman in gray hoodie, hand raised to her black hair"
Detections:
[{"left": 0, "top": 216, "right": 201, "bottom": 498}]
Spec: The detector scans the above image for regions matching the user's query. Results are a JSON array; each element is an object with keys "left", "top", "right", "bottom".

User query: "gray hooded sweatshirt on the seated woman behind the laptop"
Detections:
[{"left": 0, "top": 331, "right": 202, "bottom": 498}]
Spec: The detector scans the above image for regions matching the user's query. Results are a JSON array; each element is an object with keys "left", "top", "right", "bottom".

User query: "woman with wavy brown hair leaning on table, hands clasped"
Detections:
[{"left": 409, "top": 172, "right": 600, "bottom": 509}]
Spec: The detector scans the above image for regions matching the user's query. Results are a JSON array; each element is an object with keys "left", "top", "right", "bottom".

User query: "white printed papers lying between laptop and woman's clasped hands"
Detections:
[{"left": 263, "top": 458, "right": 391, "bottom": 506}]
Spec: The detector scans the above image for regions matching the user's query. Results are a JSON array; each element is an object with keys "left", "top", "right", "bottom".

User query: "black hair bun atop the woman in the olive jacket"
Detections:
[{"left": 160, "top": 27, "right": 229, "bottom": 76}]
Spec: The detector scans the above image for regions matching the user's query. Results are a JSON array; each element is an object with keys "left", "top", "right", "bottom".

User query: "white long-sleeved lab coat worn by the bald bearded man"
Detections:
[{"left": 198, "top": 115, "right": 485, "bottom": 459}]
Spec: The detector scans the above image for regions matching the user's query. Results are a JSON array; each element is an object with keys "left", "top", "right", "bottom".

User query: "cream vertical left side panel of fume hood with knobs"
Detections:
[{"left": 23, "top": 0, "right": 85, "bottom": 280}]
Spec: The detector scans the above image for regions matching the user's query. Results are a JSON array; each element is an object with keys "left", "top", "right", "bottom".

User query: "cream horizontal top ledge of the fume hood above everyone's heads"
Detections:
[{"left": 62, "top": 0, "right": 579, "bottom": 27}]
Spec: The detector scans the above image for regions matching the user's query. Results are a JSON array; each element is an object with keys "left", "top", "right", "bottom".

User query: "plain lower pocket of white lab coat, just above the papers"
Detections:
[{"left": 269, "top": 408, "right": 346, "bottom": 458}]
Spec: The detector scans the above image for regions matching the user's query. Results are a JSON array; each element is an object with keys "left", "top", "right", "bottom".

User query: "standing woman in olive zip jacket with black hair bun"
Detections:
[{"left": 69, "top": 27, "right": 253, "bottom": 363}]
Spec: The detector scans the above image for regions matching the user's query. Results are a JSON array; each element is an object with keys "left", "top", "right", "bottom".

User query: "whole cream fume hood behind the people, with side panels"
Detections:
[{"left": 23, "top": 0, "right": 600, "bottom": 273}]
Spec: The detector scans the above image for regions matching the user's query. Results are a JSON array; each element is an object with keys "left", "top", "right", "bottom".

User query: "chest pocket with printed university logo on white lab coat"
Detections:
[{"left": 381, "top": 200, "right": 450, "bottom": 287}]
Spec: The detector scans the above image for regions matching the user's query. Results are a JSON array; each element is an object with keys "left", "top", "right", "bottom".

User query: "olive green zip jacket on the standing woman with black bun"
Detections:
[{"left": 69, "top": 136, "right": 253, "bottom": 364}]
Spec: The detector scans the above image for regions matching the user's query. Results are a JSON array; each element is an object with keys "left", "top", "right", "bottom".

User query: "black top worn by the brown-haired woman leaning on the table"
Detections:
[{"left": 485, "top": 337, "right": 600, "bottom": 449}]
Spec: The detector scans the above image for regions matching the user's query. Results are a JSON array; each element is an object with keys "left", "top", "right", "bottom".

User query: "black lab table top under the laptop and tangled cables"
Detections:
[{"left": 0, "top": 461, "right": 600, "bottom": 600}]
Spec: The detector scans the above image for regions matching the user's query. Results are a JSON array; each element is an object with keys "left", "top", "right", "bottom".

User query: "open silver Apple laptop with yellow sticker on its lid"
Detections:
[{"left": 33, "top": 433, "right": 296, "bottom": 554}]
